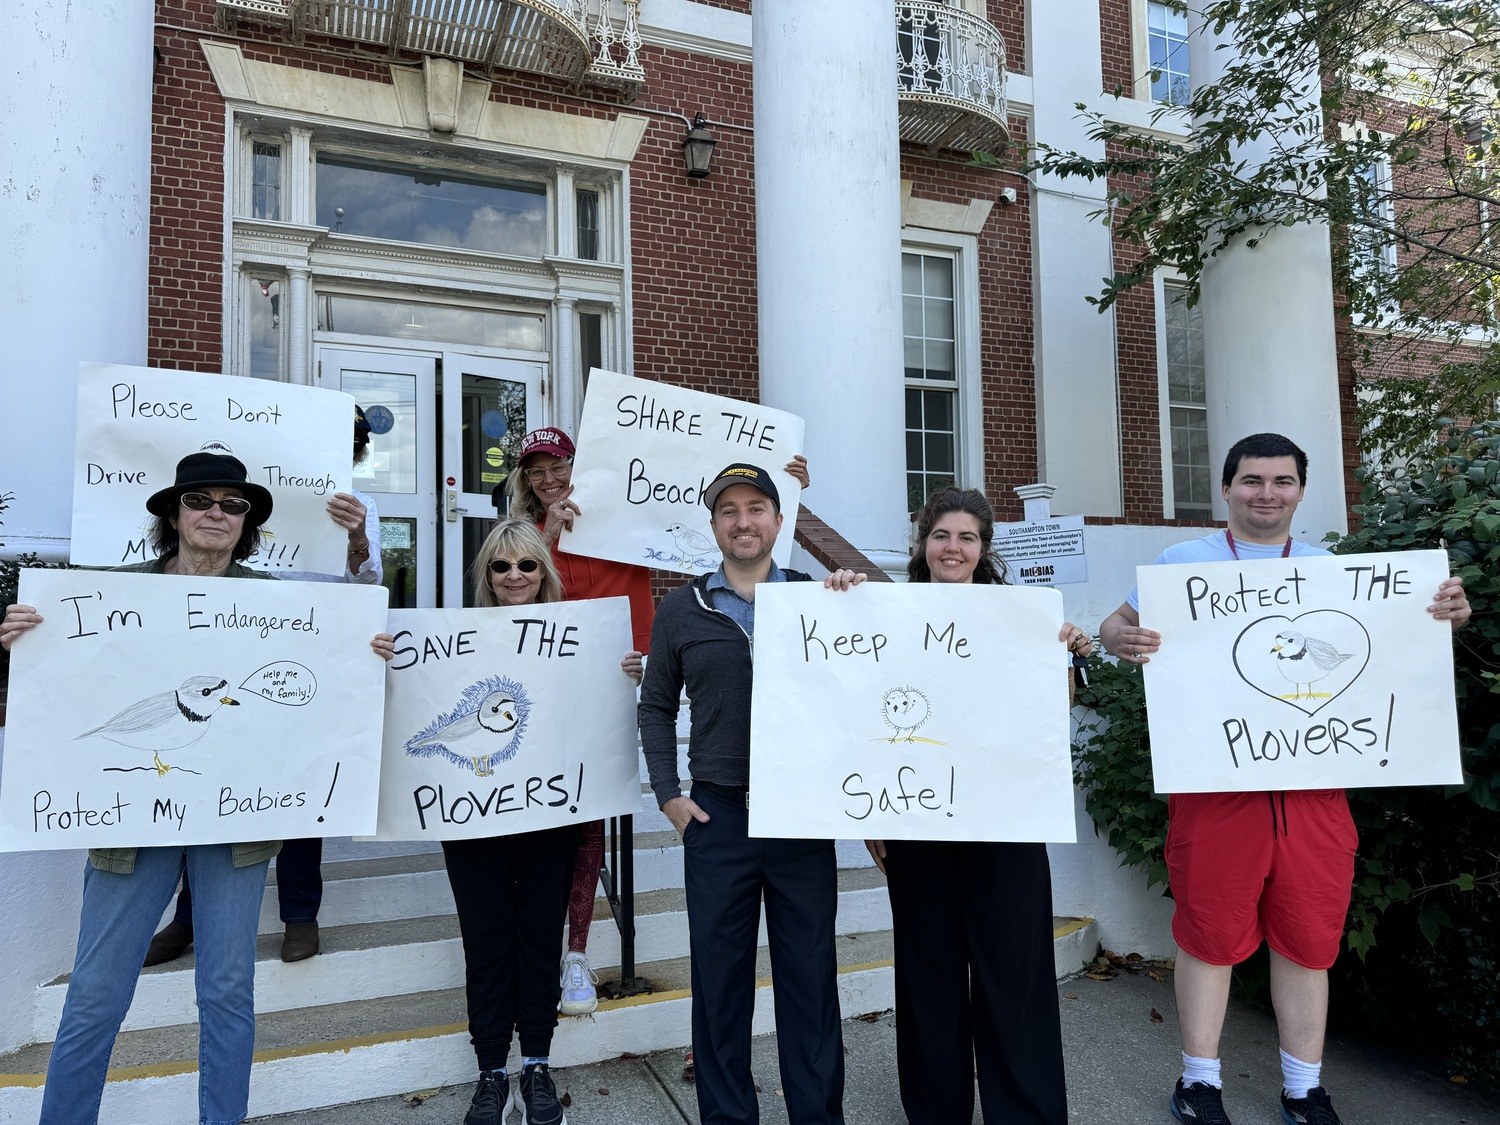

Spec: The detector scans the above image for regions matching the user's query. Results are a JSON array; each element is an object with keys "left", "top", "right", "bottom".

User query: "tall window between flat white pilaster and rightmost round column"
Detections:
[{"left": 1158, "top": 281, "right": 1214, "bottom": 519}]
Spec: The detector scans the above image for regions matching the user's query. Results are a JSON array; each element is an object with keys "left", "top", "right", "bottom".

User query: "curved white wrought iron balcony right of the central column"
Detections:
[{"left": 896, "top": 0, "right": 1010, "bottom": 153}]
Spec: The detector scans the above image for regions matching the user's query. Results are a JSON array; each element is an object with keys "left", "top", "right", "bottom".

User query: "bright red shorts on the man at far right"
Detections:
[{"left": 1167, "top": 789, "right": 1359, "bottom": 969}]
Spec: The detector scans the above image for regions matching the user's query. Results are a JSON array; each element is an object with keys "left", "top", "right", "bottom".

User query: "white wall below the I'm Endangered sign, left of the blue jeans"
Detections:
[{"left": 0, "top": 726, "right": 86, "bottom": 1053}]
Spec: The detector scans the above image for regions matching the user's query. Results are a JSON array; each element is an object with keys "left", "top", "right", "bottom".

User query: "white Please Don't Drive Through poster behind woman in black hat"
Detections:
[{"left": 71, "top": 363, "right": 354, "bottom": 575}]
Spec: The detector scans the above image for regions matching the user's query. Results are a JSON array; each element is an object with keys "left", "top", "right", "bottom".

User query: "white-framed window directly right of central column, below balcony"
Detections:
[{"left": 902, "top": 240, "right": 983, "bottom": 512}]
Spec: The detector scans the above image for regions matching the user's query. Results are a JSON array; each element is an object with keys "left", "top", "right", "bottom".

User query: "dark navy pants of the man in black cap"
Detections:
[{"left": 683, "top": 785, "right": 845, "bottom": 1125}]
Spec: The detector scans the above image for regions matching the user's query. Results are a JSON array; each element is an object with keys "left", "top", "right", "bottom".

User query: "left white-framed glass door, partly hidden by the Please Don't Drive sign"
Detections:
[{"left": 317, "top": 347, "right": 438, "bottom": 609}]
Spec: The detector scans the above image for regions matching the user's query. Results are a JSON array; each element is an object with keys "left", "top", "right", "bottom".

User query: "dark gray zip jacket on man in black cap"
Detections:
[{"left": 636, "top": 569, "right": 812, "bottom": 807}]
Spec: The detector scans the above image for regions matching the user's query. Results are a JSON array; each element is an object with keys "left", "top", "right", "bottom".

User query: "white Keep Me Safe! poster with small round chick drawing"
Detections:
[{"left": 750, "top": 582, "right": 1076, "bottom": 843}]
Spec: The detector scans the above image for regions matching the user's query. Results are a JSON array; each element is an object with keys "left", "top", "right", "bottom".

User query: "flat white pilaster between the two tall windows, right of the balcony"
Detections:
[{"left": 1032, "top": 0, "right": 1124, "bottom": 516}]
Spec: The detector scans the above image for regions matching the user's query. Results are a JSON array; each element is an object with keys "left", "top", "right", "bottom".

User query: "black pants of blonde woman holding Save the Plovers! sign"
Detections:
[{"left": 443, "top": 825, "right": 578, "bottom": 1071}]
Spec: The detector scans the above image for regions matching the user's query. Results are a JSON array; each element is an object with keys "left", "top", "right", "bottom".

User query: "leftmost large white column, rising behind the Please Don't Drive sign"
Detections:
[{"left": 0, "top": 0, "right": 153, "bottom": 558}]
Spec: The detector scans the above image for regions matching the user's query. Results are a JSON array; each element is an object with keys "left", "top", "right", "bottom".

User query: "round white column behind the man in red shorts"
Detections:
[{"left": 1188, "top": 15, "right": 1349, "bottom": 543}]
